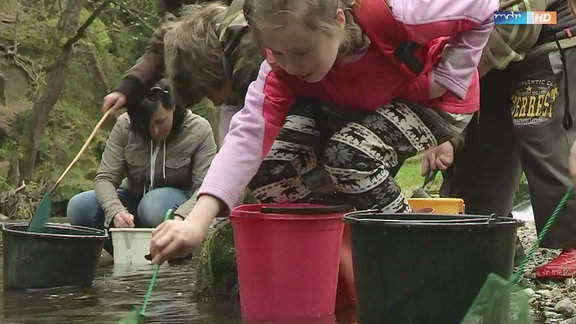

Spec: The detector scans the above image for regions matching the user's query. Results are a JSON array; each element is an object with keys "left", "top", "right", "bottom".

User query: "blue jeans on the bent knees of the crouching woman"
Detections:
[{"left": 66, "top": 187, "right": 189, "bottom": 229}]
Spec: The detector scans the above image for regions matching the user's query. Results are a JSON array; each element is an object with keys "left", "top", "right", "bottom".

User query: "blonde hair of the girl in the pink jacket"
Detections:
[{"left": 244, "top": 0, "right": 363, "bottom": 53}]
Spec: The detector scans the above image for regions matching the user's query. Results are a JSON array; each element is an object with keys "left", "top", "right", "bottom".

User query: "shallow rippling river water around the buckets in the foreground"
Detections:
[{"left": 0, "top": 252, "right": 353, "bottom": 324}]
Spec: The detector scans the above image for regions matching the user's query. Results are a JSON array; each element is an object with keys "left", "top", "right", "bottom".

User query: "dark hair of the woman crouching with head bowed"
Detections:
[{"left": 127, "top": 79, "right": 186, "bottom": 140}]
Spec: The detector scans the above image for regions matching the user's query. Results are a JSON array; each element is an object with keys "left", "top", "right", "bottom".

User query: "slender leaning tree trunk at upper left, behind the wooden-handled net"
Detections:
[{"left": 20, "top": 0, "right": 83, "bottom": 182}]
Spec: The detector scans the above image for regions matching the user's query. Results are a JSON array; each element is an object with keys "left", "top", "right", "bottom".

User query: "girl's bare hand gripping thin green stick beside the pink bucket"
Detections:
[{"left": 150, "top": 220, "right": 206, "bottom": 264}]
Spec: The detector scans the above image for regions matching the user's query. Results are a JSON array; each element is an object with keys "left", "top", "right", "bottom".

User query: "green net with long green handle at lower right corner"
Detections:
[{"left": 461, "top": 186, "right": 574, "bottom": 324}]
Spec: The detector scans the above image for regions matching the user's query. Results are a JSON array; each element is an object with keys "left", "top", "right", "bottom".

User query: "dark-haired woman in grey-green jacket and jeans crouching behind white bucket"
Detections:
[{"left": 67, "top": 80, "right": 216, "bottom": 252}]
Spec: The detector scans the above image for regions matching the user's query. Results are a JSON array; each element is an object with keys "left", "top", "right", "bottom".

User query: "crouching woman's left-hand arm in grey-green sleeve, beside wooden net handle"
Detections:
[{"left": 94, "top": 113, "right": 129, "bottom": 227}]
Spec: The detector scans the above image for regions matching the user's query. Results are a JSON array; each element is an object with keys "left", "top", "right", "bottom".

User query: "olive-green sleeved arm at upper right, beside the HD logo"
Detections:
[{"left": 478, "top": 0, "right": 548, "bottom": 77}]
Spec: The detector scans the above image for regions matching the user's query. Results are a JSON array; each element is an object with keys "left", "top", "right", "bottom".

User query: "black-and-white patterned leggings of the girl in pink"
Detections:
[{"left": 250, "top": 101, "right": 470, "bottom": 212}]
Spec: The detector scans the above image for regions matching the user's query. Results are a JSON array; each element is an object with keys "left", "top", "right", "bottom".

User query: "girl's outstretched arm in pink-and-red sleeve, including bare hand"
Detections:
[{"left": 150, "top": 62, "right": 294, "bottom": 264}]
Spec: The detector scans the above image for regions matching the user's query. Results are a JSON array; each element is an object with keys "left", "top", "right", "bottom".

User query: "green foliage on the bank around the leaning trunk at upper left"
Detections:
[{"left": 0, "top": 0, "right": 172, "bottom": 217}]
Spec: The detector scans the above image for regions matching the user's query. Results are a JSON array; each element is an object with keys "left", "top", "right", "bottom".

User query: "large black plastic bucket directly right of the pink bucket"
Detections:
[{"left": 344, "top": 212, "right": 524, "bottom": 324}]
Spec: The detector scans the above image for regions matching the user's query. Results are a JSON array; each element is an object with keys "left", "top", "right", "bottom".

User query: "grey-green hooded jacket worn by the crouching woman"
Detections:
[{"left": 94, "top": 111, "right": 216, "bottom": 227}]
